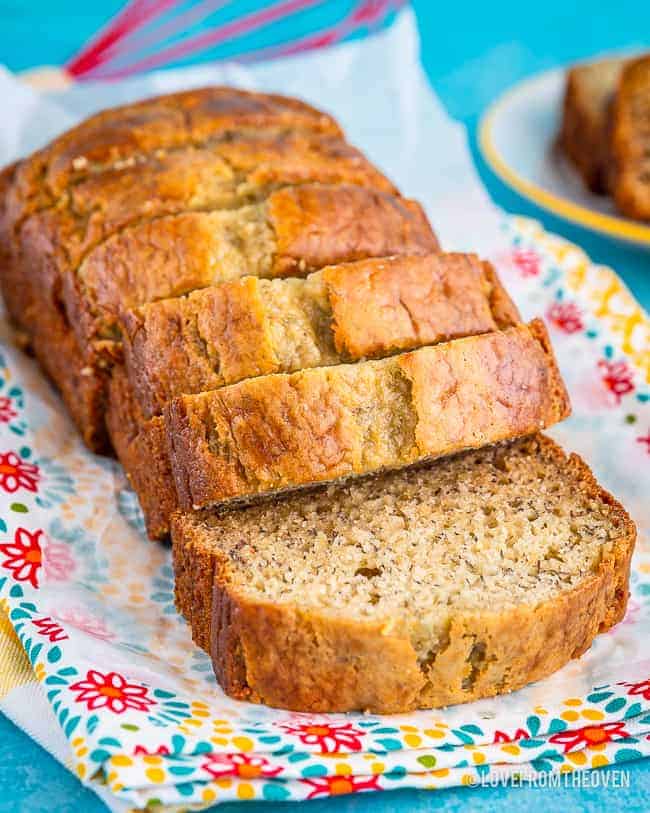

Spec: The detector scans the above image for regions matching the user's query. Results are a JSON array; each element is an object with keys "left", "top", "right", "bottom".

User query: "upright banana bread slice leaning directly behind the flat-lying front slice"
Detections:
[{"left": 164, "top": 320, "right": 569, "bottom": 509}]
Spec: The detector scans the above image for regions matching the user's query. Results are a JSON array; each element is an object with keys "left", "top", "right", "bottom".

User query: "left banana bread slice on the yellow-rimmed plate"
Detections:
[{"left": 560, "top": 58, "right": 625, "bottom": 194}]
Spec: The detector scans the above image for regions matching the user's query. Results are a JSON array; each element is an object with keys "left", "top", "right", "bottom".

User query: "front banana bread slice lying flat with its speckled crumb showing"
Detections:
[{"left": 172, "top": 435, "right": 635, "bottom": 713}]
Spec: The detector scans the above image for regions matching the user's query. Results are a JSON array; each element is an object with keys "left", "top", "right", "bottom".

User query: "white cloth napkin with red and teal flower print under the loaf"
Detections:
[{"left": 0, "top": 213, "right": 650, "bottom": 809}]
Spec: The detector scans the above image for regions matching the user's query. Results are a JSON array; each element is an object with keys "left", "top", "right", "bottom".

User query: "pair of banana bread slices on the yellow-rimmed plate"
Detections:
[{"left": 560, "top": 54, "right": 650, "bottom": 221}]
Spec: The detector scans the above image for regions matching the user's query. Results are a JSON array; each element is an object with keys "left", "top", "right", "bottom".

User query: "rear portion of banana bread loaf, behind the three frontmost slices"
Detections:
[{"left": 0, "top": 88, "right": 437, "bottom": 451}]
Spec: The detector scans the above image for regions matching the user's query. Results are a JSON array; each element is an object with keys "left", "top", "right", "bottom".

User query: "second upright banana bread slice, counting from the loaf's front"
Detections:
[{"left": 123, "top": 254, "right": 520, "bottom": 417}]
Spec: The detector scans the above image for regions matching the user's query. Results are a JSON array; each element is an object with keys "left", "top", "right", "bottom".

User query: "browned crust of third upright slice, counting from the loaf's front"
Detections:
[{"left": 71, "top": 184, "right": 438, "bottom": 354}]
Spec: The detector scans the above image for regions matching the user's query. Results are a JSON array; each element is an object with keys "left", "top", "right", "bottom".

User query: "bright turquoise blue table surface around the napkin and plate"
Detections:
[{"left": 0, "top": 0, "right": 650, "bottom": 813}]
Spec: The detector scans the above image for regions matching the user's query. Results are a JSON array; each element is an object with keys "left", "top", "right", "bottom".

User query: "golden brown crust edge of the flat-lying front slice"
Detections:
[{"left": 172, "top": 436, "right": 636, "bottom": 713}]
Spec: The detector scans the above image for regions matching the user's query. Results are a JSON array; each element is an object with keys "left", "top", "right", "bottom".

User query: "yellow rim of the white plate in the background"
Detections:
[{"left": 479, "top": 80, "right": 650, "bottom": 243}]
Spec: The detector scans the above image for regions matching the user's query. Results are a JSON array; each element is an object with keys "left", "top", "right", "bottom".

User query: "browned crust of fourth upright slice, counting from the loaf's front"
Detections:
[{"left": 17, "top": 132, "right": 396, "bottom": 325}]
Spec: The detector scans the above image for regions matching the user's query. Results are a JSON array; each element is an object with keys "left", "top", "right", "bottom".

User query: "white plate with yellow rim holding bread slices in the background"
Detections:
[{"left": 479, "top": 68, "right": 650, "bottom": 248}]
